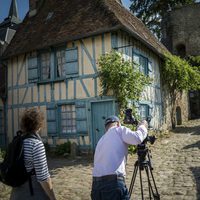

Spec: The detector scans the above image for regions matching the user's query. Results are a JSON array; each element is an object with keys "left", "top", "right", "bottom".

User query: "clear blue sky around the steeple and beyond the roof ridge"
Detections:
[{"left": 0, "top": 0, "right": 133, "bottom": 23}]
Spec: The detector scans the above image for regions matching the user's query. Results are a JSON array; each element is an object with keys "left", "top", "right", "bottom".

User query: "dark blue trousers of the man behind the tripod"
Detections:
[{"left": 91, "top": 177, "right": 130, "bottom": 200}]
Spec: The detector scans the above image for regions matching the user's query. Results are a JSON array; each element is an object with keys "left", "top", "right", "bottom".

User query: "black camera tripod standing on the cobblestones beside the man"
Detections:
[{"left": 129, "top": 144, "right": 160, "bottom": 200}]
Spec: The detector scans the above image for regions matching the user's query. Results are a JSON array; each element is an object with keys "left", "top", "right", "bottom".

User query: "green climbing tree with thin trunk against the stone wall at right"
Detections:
[{"left": 162, "top": 54, "right": 200, "bottom": 128}]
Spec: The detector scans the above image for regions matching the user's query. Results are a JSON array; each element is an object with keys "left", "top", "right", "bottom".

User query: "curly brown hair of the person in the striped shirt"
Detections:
[{"left": 20, "top": 108, "right": 44, "bottom": 132}]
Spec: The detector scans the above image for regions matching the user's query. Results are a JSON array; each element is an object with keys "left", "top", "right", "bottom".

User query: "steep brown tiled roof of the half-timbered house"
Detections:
[{"left": 4, "top": 0, "right": 167, "bottom": 58}]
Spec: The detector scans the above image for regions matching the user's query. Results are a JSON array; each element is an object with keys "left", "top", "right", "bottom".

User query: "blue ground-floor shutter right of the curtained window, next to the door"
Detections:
[{"left": 76, "top": 102, "right": 88, "bottom": 134}]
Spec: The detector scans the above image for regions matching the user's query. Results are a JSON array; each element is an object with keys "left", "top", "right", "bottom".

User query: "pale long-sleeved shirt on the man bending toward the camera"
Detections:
[{"left": 93, "top": 125, "right": 147, "bottom": 177}]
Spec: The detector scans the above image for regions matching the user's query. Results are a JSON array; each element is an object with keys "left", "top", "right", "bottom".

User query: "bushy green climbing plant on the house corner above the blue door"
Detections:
[{"left": 98, "top": 51, "right": 151, "bottom": 109}]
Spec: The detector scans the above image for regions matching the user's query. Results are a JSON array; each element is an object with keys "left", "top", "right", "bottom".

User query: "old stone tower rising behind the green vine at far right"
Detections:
[{"left": 162, "top": 3, "right": 200, "bottom": 119}]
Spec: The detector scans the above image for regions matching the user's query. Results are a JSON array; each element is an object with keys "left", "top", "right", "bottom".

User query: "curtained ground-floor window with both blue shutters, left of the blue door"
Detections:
[{"left": 47, "top": 101, "right": 88, "bottom": 137}]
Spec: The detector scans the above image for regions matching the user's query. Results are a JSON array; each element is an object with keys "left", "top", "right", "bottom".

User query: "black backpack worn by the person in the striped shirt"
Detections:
[{"left": 0, "top": 131, "right": 40, "bottom": 189}]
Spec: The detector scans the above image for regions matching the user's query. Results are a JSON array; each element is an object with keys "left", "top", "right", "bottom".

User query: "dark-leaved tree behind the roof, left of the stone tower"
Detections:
[{"left": 130, "top": 0, "right": 196, "bottom": 39}]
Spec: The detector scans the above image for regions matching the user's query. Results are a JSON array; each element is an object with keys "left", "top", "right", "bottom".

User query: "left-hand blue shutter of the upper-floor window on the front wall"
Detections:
[{"left": 28, "top": 56, "right": 39, "bottom": 83}]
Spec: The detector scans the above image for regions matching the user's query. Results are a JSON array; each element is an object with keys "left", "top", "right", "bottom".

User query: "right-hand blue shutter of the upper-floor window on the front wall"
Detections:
[{"left": 65, "top": 48, "right": 78, "bottom": 75}]
